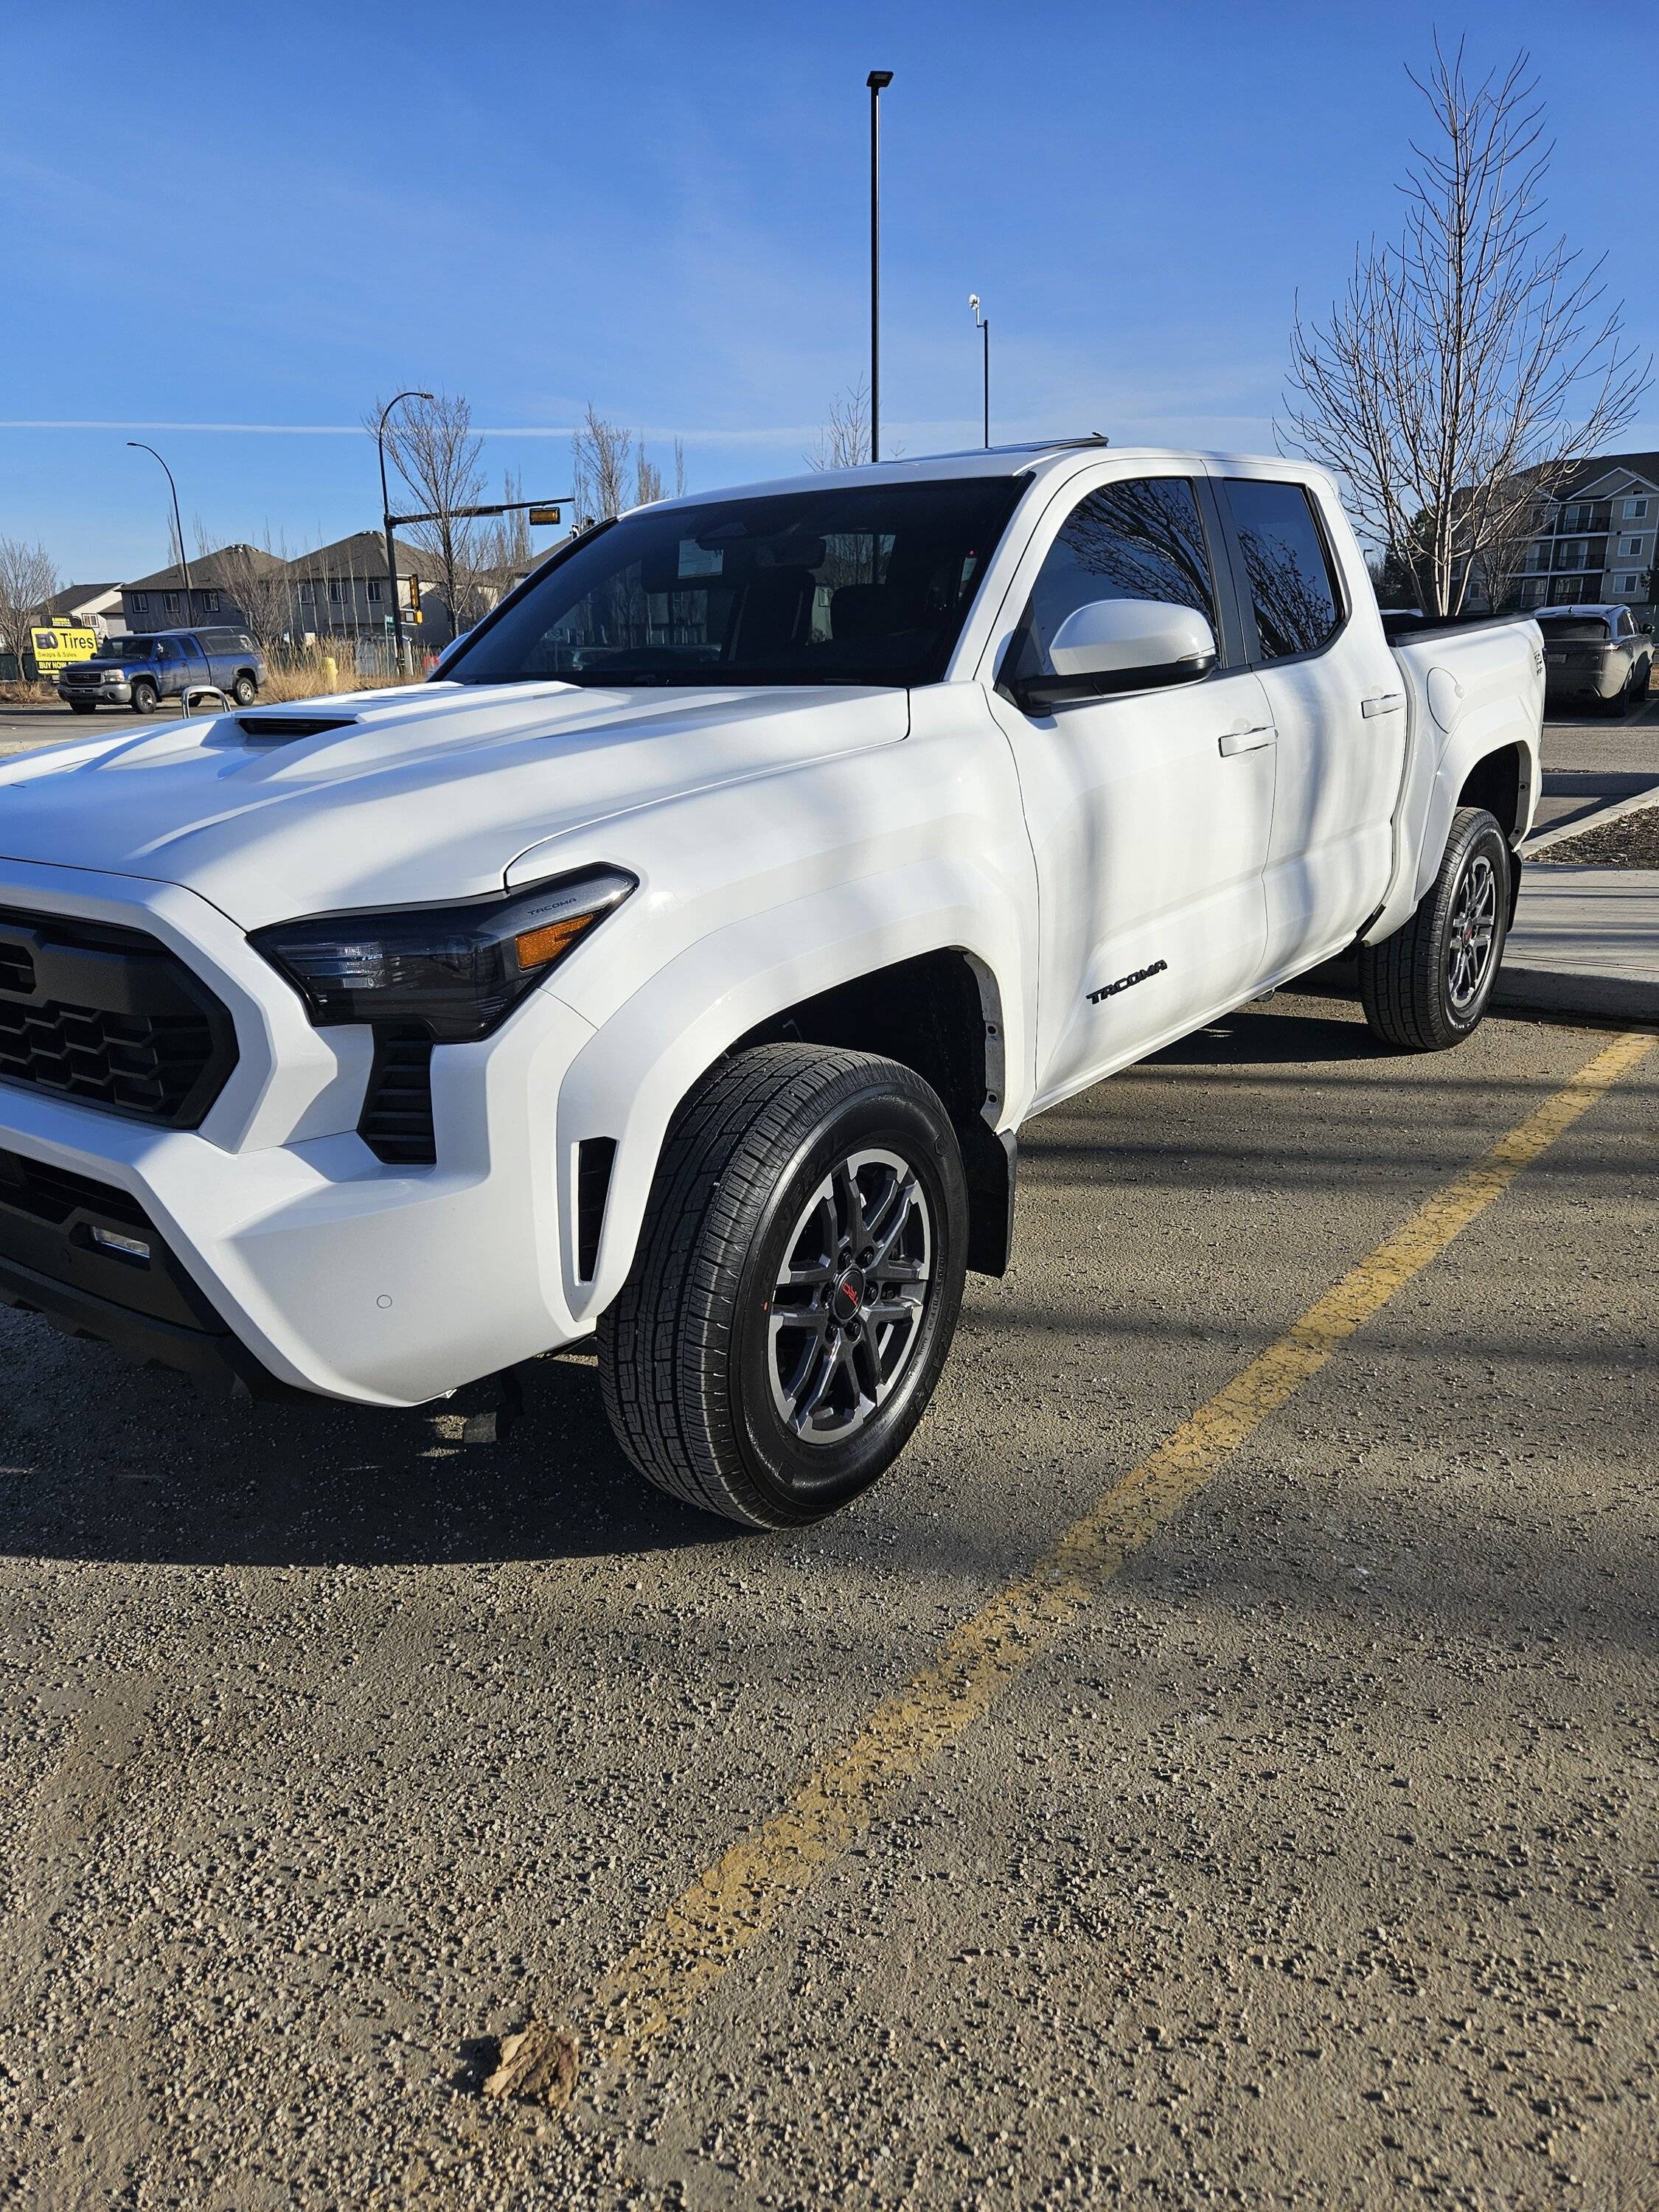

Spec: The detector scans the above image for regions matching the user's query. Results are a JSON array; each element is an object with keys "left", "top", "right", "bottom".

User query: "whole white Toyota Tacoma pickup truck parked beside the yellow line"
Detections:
[{"left": 0, "top": 440, "right": 1544, "bottom": 1526}]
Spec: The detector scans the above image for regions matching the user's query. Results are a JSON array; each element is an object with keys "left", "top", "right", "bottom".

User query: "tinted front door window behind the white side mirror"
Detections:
[{"left": 1009, "top": 476, "right": 1219, "bottom": 679}]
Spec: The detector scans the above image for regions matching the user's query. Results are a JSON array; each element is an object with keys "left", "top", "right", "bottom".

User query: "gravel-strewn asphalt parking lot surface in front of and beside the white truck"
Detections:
[{"left": 0, "top": 995, "right": 1659, "bottom": 2212}]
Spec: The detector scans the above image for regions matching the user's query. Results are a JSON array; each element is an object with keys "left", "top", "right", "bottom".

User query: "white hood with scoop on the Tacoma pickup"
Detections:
[{"left": 0, "top": 684, "right": 909, "bottom": 929}]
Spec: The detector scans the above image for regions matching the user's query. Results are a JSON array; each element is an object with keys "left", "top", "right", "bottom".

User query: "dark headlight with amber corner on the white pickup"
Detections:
[{"left": 248, "top": 867, "right": 637, "bottom": 1044}]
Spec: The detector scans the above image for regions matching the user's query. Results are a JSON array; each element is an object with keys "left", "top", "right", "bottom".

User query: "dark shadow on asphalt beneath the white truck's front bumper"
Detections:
[{"left": 0, "top": 1314, "right": 743, "bottom": 1568}]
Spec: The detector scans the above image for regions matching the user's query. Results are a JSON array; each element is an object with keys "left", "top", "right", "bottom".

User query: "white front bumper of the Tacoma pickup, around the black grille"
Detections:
[{"left": 0, "top": 860, "right": 597, "bottom": 1405}]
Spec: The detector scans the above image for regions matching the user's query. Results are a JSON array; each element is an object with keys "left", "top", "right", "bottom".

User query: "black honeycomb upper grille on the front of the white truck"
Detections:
[{"left": 0, "top": 909, "right": 237, "bottom": 1128}]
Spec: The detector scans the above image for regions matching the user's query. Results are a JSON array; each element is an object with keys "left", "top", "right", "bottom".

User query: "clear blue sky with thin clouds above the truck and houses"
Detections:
[{"left": 0, "top": 0, "right": 1659, "bottom": 580}]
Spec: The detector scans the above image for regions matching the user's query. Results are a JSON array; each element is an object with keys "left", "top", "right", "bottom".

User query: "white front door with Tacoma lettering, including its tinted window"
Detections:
[{"left": 998, "top": 476, "right": 1274, "bottom": 1102}]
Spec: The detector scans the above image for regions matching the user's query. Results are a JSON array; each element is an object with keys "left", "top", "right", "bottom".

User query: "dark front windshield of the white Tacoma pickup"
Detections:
[{"left": 442, "top": 476, "right": 1024, "bottom": 684}]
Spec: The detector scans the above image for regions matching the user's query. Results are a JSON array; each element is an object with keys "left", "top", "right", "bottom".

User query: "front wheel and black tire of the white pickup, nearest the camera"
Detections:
[{"left": 599, "top": 1044, "right": 967, "bottom": 1528}]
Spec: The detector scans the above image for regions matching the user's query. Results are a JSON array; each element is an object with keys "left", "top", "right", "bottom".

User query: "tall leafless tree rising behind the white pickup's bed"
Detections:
[{"left": 1281, "top": 38, "right": 1648, "bottom": 615}]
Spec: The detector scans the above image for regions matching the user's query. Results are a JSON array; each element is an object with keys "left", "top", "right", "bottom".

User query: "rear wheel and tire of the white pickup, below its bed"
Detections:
[{"left": 1358, "top": 807, "right": 1511, "bottom": 1053}]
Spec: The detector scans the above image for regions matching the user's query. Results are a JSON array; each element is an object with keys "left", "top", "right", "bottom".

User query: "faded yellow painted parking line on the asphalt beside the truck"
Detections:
[{"left": 500, "top": 1035, "right": 1655, "bottom": 2097}]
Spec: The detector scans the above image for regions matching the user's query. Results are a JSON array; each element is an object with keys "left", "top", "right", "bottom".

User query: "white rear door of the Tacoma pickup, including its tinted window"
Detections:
[{"left": 1214, "top": 462, "right": 1407, "bottom": 975}]
